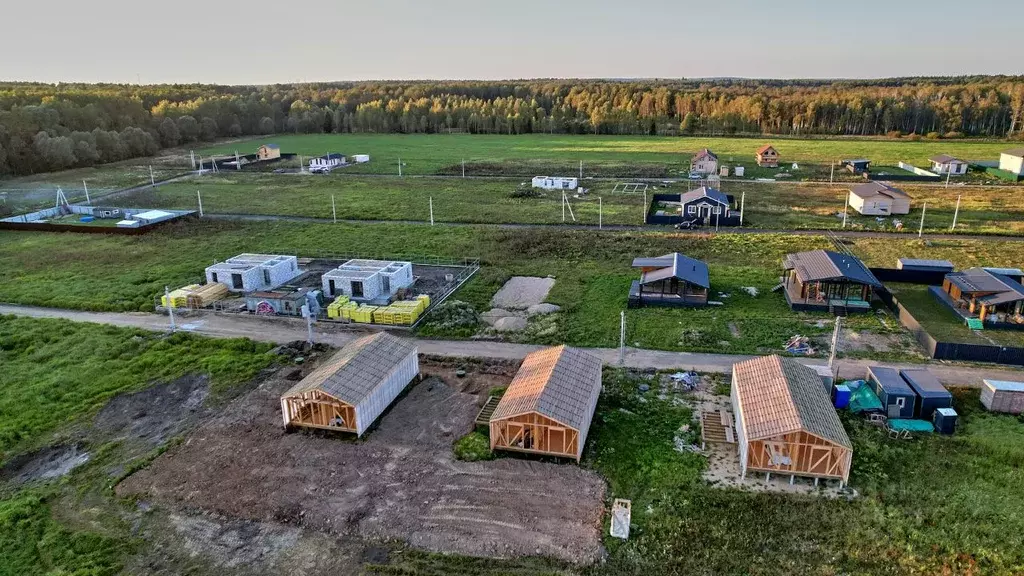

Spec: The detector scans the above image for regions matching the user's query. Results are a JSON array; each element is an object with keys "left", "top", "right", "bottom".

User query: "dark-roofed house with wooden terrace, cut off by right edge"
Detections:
[{"left": 932, "top": 268, "right": 1024, "bottom": 325}]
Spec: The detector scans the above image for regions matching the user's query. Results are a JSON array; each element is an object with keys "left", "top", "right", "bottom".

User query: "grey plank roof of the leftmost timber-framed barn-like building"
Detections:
[{"left": 284, "top": 332, "right": 416, "bottom": 406}]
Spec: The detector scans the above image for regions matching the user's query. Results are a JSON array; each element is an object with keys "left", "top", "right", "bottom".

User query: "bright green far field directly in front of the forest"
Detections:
[{"left": 193, "top": 134, "right": 1008, "bottom": 175}]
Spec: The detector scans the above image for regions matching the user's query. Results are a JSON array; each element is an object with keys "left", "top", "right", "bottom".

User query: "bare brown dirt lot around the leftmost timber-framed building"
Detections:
[{"left": 118, "top": 358, "right": 605, "bottom": 563}]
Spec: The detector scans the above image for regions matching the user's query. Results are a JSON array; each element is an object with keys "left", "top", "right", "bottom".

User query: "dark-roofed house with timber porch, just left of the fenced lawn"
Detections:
[{"left": 780, "top": 250, "right": 882, "bottom": 315}]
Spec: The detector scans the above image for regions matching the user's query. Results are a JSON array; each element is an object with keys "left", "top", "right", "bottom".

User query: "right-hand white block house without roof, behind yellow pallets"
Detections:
[{"left": 323, "top": 259, "right": 413, "bottom": 304}]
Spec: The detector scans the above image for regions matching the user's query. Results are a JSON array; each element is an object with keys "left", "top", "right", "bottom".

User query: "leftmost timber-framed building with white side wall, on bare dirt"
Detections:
[{"left": 281, "top": 332, "right": 420, "bottom": 436}]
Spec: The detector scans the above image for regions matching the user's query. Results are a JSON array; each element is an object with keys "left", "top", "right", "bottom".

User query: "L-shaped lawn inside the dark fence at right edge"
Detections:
[{"left": 887, "top": 284, "right": 1024, "bottom": 346}]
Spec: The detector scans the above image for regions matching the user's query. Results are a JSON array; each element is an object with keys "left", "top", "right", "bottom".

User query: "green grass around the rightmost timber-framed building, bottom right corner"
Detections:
[{"left": 584, "top": 370, "right": 1024, "bottom": 575}]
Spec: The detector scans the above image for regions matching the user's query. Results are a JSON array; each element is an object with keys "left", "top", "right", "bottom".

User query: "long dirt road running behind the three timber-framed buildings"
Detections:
[{"left": 0, "top": 304, "right": 1024, "bottom": 386}]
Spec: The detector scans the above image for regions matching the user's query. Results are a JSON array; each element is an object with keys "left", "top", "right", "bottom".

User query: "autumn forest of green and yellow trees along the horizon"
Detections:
[{"left": 0, "top": 76, "right": 1024, "bottom": 174}]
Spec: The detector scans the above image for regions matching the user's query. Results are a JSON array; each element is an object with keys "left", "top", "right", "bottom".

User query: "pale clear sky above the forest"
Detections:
[{"left": 0, "top": 0, "right": 1024, "bottom": 84}]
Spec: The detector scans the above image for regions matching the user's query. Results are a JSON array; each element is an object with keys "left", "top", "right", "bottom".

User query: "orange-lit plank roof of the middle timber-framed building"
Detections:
[{"left": 490, "top": 345, "right": 601, "bottom": 430}]
